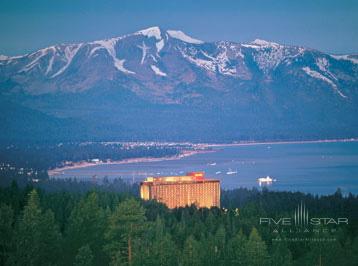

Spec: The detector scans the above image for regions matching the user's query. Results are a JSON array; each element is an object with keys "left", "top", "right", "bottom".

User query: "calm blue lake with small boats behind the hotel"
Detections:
[{"left": 53, "top": 142, "right": 358, "bottom": 194}]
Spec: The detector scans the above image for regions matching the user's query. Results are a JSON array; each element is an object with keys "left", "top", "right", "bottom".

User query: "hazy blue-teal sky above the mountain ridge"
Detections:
[{"left": 0, "top": 0, "right": 358, "bottom": 55}]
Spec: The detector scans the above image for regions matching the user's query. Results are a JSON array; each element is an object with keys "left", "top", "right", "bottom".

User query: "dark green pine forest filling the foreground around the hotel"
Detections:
[{"left": 0, "top": 183, "right": 358, "bottom": 266}]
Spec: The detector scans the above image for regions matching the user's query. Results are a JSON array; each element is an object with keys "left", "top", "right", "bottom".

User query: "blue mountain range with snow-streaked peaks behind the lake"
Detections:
[{"left": 0, "top": 27, "right": 358, "bottom": 142}]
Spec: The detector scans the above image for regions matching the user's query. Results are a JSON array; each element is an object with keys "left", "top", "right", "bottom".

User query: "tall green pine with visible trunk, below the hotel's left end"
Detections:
[{"left": 105, "top": 198, "right": 146, "bottom": 265}]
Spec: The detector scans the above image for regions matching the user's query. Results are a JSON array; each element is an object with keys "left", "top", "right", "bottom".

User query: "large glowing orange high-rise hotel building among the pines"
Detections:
[{"left": 140, "top": 172, "right": 220, "bottom": 209}]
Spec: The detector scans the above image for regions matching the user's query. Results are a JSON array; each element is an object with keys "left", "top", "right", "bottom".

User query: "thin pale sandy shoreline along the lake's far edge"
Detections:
[{"left": 47, "top": 138, "right": 358, "bottom": 178}]
